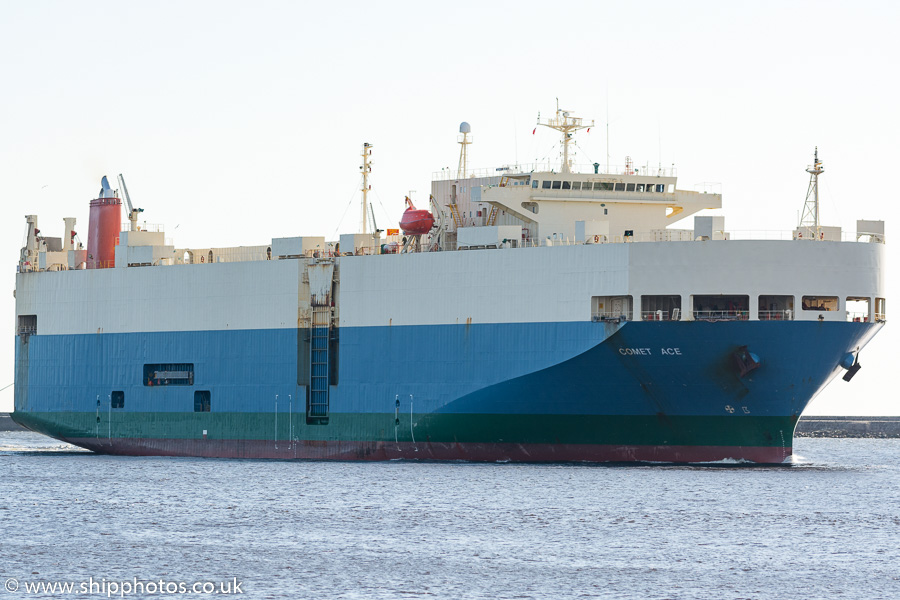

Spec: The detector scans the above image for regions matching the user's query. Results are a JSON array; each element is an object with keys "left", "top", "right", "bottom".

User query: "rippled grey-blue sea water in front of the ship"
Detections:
[{"left": 0, "top": 433, "right": 900, "bottom": 599}]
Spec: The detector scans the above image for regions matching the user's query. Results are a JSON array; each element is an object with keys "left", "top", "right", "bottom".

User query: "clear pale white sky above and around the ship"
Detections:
[{"left": 0, "top": 0, "right": 900, "bottom": 414}]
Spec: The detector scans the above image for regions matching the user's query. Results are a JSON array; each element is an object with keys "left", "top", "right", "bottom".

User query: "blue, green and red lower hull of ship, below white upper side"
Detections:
[{"left": 13, "top": 322, "right": 880, "bottom": 463}]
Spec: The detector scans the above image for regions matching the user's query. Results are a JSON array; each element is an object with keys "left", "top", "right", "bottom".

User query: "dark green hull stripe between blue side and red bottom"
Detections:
[{"left": 13, "top": 411, "right": 797, "bottom": 446}]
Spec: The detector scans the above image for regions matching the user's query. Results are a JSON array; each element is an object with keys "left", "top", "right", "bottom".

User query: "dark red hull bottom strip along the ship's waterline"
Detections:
[{"left": 65, "top": 437, "right": 791, "bottom": 464}]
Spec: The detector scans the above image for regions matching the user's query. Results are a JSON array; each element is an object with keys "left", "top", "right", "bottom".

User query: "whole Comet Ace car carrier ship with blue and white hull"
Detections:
[{"left": 12, "top": 110, "right": 886, "bottom": 464}]
